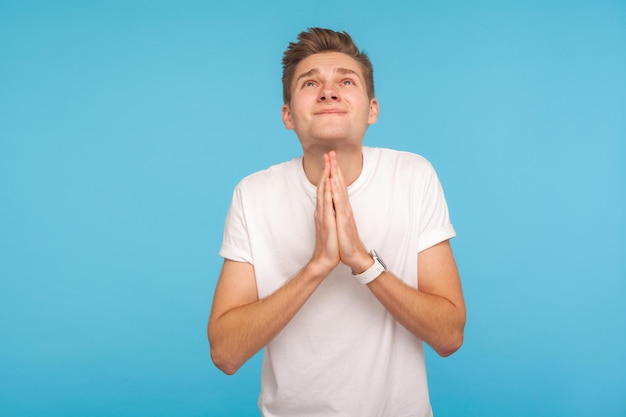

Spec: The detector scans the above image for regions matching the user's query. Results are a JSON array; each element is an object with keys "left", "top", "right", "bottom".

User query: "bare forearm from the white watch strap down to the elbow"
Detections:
[{"left": 367, "top": 271, "right": 465, "bottom": 356}]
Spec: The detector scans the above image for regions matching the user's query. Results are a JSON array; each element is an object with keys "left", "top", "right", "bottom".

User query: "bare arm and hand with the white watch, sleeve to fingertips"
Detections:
[{"left": 330, "top": 153, "right": 465, "bottom": 356}]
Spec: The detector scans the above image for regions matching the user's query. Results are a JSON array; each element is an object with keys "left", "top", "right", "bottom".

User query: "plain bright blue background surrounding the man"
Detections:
[{"left": 0, "top": 0, "right": 626, "bottom": 416}]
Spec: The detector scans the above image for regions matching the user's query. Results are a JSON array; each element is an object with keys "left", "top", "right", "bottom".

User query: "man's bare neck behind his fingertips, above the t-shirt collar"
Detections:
[{"left": 302, "top": 144, "right": 363, "bottom": 185}]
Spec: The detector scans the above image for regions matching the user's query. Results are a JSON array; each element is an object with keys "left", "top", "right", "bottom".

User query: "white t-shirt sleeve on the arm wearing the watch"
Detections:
[{"left": 418, "top": 164, "right": 456, "bottom": 252}]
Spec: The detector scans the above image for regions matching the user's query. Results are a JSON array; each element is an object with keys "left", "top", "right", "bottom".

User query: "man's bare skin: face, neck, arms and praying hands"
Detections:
[{"left": 208, "top": 52, "right": 465, "bottom": 374}]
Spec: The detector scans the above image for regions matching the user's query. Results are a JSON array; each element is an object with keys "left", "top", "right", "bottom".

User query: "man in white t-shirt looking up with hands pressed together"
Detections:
[{"left": 208, "top": 28, "right": 465, "bottom": 417}]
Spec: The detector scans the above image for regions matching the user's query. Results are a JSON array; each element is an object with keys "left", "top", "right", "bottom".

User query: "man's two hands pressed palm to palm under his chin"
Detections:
[{"left": 312, "top": 151, "right": 374, "bottom": 275}]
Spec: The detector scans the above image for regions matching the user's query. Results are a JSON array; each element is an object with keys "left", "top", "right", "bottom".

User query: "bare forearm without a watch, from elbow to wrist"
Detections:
[{"left": 208, "top": 264, "right": 327, "bottom": 374}]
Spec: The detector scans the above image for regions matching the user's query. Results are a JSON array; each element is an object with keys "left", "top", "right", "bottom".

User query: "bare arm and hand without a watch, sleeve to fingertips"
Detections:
[{"left": 207, "top": 158, "right": 339, "bottom": 374}]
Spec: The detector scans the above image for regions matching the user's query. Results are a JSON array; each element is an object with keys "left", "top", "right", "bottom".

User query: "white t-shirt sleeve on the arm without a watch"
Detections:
[{"left": 219, "top": 184, "right": 253, "bottom": 263}]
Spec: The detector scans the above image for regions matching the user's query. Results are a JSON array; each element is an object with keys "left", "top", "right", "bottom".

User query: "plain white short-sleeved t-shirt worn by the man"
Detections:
[{"left": 220, "top": 147, "right": 455, "bottom": 417}]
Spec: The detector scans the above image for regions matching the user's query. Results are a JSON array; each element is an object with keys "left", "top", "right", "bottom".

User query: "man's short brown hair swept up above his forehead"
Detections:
[{"left": 283, "top": 28, "right": 374, "bottom": 104}]
